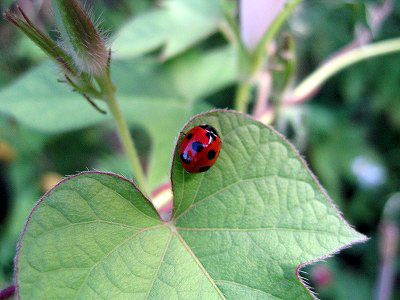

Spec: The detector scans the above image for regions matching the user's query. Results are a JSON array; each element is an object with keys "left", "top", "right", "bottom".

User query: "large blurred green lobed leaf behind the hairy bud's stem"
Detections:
[{"left": 0, "top": 47, "right": 236, "bottom": 189}]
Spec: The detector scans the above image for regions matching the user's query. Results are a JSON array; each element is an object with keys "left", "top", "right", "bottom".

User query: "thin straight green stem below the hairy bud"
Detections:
[{"left": 97, "top": 76, "right": 148, "bottom": 196}]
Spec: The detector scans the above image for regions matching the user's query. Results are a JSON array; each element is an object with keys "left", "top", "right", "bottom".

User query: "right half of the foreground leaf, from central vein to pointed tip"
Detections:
[{"left": 172, "top": 111, "right": 365, "bottom": 299}]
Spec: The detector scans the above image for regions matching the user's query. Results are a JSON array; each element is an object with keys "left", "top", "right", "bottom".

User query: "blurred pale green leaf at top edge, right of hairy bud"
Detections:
[{"left": 113, "top": 0, "right": 224, "bottom": 59}]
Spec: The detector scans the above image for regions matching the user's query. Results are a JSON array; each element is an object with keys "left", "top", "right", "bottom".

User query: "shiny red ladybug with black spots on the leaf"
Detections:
[{"left": 179, "top": 124, "right": 221, "bottom": 173}]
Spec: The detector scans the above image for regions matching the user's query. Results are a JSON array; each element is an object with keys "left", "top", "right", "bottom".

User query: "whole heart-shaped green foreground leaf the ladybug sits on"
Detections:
[{"left": 16, "top": 111, "right": 365, "bottom": 299}]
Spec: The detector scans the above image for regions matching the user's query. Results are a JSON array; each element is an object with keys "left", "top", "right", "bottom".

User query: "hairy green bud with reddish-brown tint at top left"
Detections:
[{"left": 53, "top": 0, "right": 108, "bottom": 75}]
